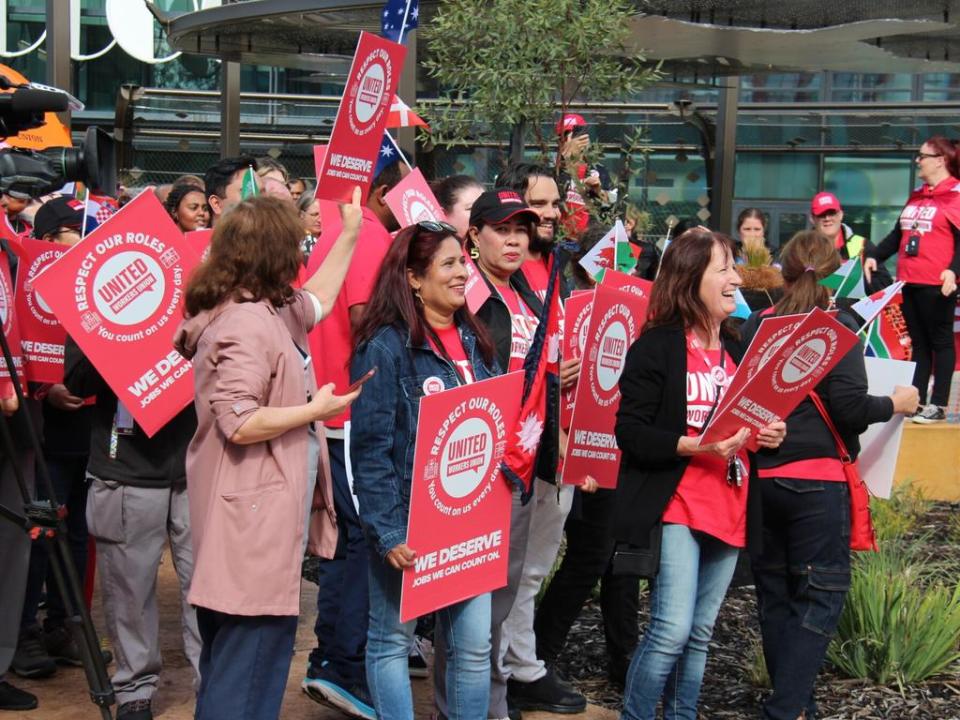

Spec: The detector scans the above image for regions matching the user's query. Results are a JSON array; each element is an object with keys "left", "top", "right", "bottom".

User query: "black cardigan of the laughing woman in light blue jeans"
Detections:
[{"left": 613, "top": 326, "right": 761, "bottom": 546}]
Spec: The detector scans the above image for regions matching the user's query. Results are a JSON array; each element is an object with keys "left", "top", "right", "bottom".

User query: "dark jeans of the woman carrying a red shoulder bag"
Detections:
[{"left": 752, "top": 478, "right": 850, "bottom": 720}]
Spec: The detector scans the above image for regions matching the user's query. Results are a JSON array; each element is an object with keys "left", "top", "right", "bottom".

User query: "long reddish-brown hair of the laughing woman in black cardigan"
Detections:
[{"left": 644, "top": 228, "right": 737, "bottom": 337}]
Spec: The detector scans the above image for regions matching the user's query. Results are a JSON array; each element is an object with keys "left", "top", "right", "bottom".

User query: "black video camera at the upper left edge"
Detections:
[{"left": 0, "top": 76, "right": 117, "bottom": 198}]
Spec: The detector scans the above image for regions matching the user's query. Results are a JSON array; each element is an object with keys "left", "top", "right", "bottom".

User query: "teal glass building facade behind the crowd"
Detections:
[{"left": 0, "top": 0, "right": 960, "bottom": 245}]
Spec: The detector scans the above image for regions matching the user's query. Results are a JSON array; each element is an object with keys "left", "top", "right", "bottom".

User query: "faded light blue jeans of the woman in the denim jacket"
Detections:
[{"left": 367, "top": 551, "right": 490, "bottom": 720}]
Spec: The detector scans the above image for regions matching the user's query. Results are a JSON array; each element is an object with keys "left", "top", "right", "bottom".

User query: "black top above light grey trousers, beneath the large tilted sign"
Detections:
[{"left": 63, "top": 337, "right": 197, "bottom": 488}]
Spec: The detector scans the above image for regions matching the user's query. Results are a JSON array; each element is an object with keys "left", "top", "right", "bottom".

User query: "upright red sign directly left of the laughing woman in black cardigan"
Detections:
[{"left": 561, "top": 284, "right": 650, "bottom": 488}]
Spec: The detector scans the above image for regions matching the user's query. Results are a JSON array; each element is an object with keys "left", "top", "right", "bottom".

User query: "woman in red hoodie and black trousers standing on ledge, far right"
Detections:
[{"left": 863, "top": 135, "right": 960, "bottom": 423}]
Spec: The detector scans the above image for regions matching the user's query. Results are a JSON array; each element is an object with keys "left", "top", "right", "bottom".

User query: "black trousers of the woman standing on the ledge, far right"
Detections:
[{"left": 903, "top": 285, "right": 957, "bottom": 407}]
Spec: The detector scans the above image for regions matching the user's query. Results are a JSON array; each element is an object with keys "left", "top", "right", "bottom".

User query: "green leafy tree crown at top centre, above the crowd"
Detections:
[{"left": 418, "top": 0, "right": 659, "bottom": 145}]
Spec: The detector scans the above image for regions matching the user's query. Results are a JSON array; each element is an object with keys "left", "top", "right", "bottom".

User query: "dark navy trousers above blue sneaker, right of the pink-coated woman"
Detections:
[{"left": 310, "top": 439, "right": 368, "bottom": 687}]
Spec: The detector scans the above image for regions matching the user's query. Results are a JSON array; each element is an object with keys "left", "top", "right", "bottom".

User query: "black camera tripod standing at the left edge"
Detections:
[{"left": 0, "top": 324, "right": 116, "bottom": 720}]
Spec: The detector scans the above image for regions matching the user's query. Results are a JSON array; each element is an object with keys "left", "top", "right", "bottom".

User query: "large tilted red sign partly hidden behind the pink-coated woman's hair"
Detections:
[{"left": 34, "top": 192, "right": 198, "bottom": 436}]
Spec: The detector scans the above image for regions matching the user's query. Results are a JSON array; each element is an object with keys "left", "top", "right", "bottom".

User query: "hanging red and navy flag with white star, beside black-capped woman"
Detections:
[{"left": 500, "top": 244, "right": 566, "bottom": 503}]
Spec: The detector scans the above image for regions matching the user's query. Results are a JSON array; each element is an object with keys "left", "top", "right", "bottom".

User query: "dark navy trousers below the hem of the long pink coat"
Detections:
[{"left": 194, "top": 607, "right": 297, "bottom": 720}]
